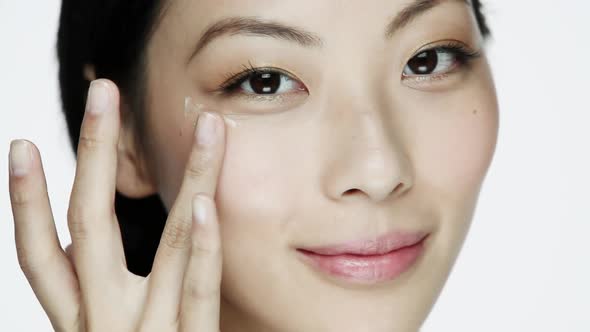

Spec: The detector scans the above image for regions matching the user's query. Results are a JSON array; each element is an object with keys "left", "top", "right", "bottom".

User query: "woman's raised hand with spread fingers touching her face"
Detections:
[{"left": 9, "top": 79, "right": 225, "bottom": 332}]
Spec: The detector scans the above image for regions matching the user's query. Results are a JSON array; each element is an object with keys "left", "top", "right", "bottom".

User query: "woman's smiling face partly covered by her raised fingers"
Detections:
[{"left": 139, "top": 0, "right": 498, "bottom": 331}]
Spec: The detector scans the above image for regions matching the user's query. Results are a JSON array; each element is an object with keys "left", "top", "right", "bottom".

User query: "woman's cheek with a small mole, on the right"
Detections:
[{"left": 410, "top": 66, "right": 499, "bottom": 209}]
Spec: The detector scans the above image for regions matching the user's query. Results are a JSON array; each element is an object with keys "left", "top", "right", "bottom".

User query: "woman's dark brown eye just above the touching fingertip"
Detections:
[{"left": 222, "top": 68, "right": 307, "bottom": 96}]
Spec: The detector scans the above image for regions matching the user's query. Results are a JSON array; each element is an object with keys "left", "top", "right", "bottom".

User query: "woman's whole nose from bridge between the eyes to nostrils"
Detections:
[{"left": 324, "top": 81, "right": 412, "bottom": 201}]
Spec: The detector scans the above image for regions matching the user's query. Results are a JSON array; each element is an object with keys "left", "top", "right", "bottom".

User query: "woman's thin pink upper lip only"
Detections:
[{"left": 299, "top": 231, "right": 429, "bottom": 256}]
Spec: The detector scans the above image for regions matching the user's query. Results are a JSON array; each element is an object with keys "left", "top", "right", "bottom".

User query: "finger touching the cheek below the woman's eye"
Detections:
[{"left": 147, "top": 113, "right": 225, "bottom": 321}]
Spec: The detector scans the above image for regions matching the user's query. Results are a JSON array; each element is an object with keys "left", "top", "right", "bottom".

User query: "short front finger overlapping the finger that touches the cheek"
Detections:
[{"left": 180, "top": 195, "right": 222, "bottom": 332}]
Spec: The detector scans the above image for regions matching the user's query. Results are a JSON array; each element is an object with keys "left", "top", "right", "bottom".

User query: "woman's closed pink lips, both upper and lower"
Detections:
[{"left": 297, "top": 231, "right": 429, "bottom": 283}]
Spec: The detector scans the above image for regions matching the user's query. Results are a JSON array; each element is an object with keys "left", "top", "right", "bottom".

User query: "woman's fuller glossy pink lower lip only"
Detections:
[{"left": 298, "top": 239, "right": 424, "bottom": 284}]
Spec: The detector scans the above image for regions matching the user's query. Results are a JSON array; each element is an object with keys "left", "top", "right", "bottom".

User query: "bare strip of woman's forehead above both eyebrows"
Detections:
[{"left": 156, "top": 0, "right": 472, "bottom": 51}]
